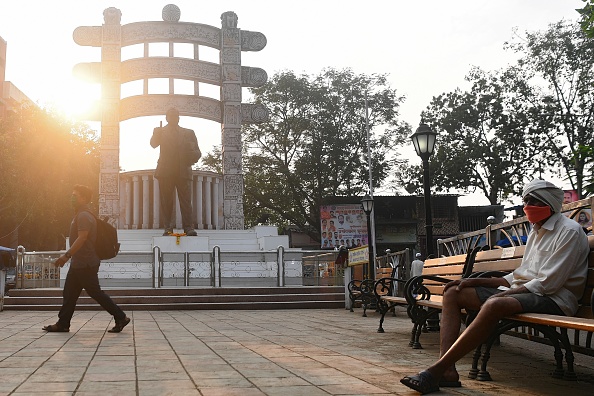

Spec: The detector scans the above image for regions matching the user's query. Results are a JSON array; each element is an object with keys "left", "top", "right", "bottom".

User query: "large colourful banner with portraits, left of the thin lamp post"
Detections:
[{"left": 320, "top": 204, "right": 367, "bottom": 249}]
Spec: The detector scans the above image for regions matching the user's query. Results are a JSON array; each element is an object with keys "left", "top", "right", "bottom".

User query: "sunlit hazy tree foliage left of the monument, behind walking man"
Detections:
[{"left": 0, "top": 106, "right": 99, "bottom": 250}]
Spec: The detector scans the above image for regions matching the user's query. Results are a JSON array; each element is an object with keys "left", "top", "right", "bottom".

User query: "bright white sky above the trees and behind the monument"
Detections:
[{"left": 0, "top": 0, "right": 583, "bottom": 205}]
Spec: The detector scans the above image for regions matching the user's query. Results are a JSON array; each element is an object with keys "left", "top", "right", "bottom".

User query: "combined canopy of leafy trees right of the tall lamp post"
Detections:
[{"left": 398, "top": 21, "right": 594, "bottom": 204}]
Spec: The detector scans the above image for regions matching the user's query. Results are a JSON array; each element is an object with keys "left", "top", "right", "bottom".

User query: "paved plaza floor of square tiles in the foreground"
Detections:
[{"left": 0, "top": 309, "right": 594, "bottom": 396}]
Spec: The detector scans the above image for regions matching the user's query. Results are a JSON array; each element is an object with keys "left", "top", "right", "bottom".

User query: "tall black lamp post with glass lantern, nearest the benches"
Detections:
[{"left": 410, "top": 121, "right": 437, "bottom": 258}]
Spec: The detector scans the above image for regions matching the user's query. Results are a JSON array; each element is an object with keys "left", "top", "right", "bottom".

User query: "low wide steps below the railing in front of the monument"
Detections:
[{"left": 4, "top": 286, "right": 344, "bottom": 311}]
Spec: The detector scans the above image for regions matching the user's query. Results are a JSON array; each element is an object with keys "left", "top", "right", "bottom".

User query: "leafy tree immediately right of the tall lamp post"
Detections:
[{"left": 399, "top": 68, "right": 537, "bottom": 205}]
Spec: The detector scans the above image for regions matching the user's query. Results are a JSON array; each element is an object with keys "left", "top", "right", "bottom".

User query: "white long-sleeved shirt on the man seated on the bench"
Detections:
[{"left": 505, "top": 213, "right": 590, "bottom": 316}]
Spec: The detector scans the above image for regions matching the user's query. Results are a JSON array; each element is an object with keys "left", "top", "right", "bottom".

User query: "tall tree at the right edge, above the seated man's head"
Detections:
[{"left": 510, "top": 21, "right": 594, "bottom": 198}]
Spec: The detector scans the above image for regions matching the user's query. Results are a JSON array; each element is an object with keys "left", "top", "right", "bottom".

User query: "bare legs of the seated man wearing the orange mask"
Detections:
[{"left": 427, "top": 296, "right": 522, "bottom": 381}]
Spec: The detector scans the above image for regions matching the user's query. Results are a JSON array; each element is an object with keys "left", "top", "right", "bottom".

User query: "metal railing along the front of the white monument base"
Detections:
[{"left": 16, "top": 246, "right": 344, "bottom": 289}]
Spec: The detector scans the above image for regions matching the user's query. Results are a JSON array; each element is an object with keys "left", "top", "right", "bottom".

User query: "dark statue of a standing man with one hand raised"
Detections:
[{"left": 151, "top": 108, "right": 202, "bottom": 236}]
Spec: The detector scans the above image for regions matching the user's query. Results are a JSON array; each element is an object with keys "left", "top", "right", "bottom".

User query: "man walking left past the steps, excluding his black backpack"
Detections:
[{"left": 43, "top": 185, "right": 130, "bottom": 333}]
